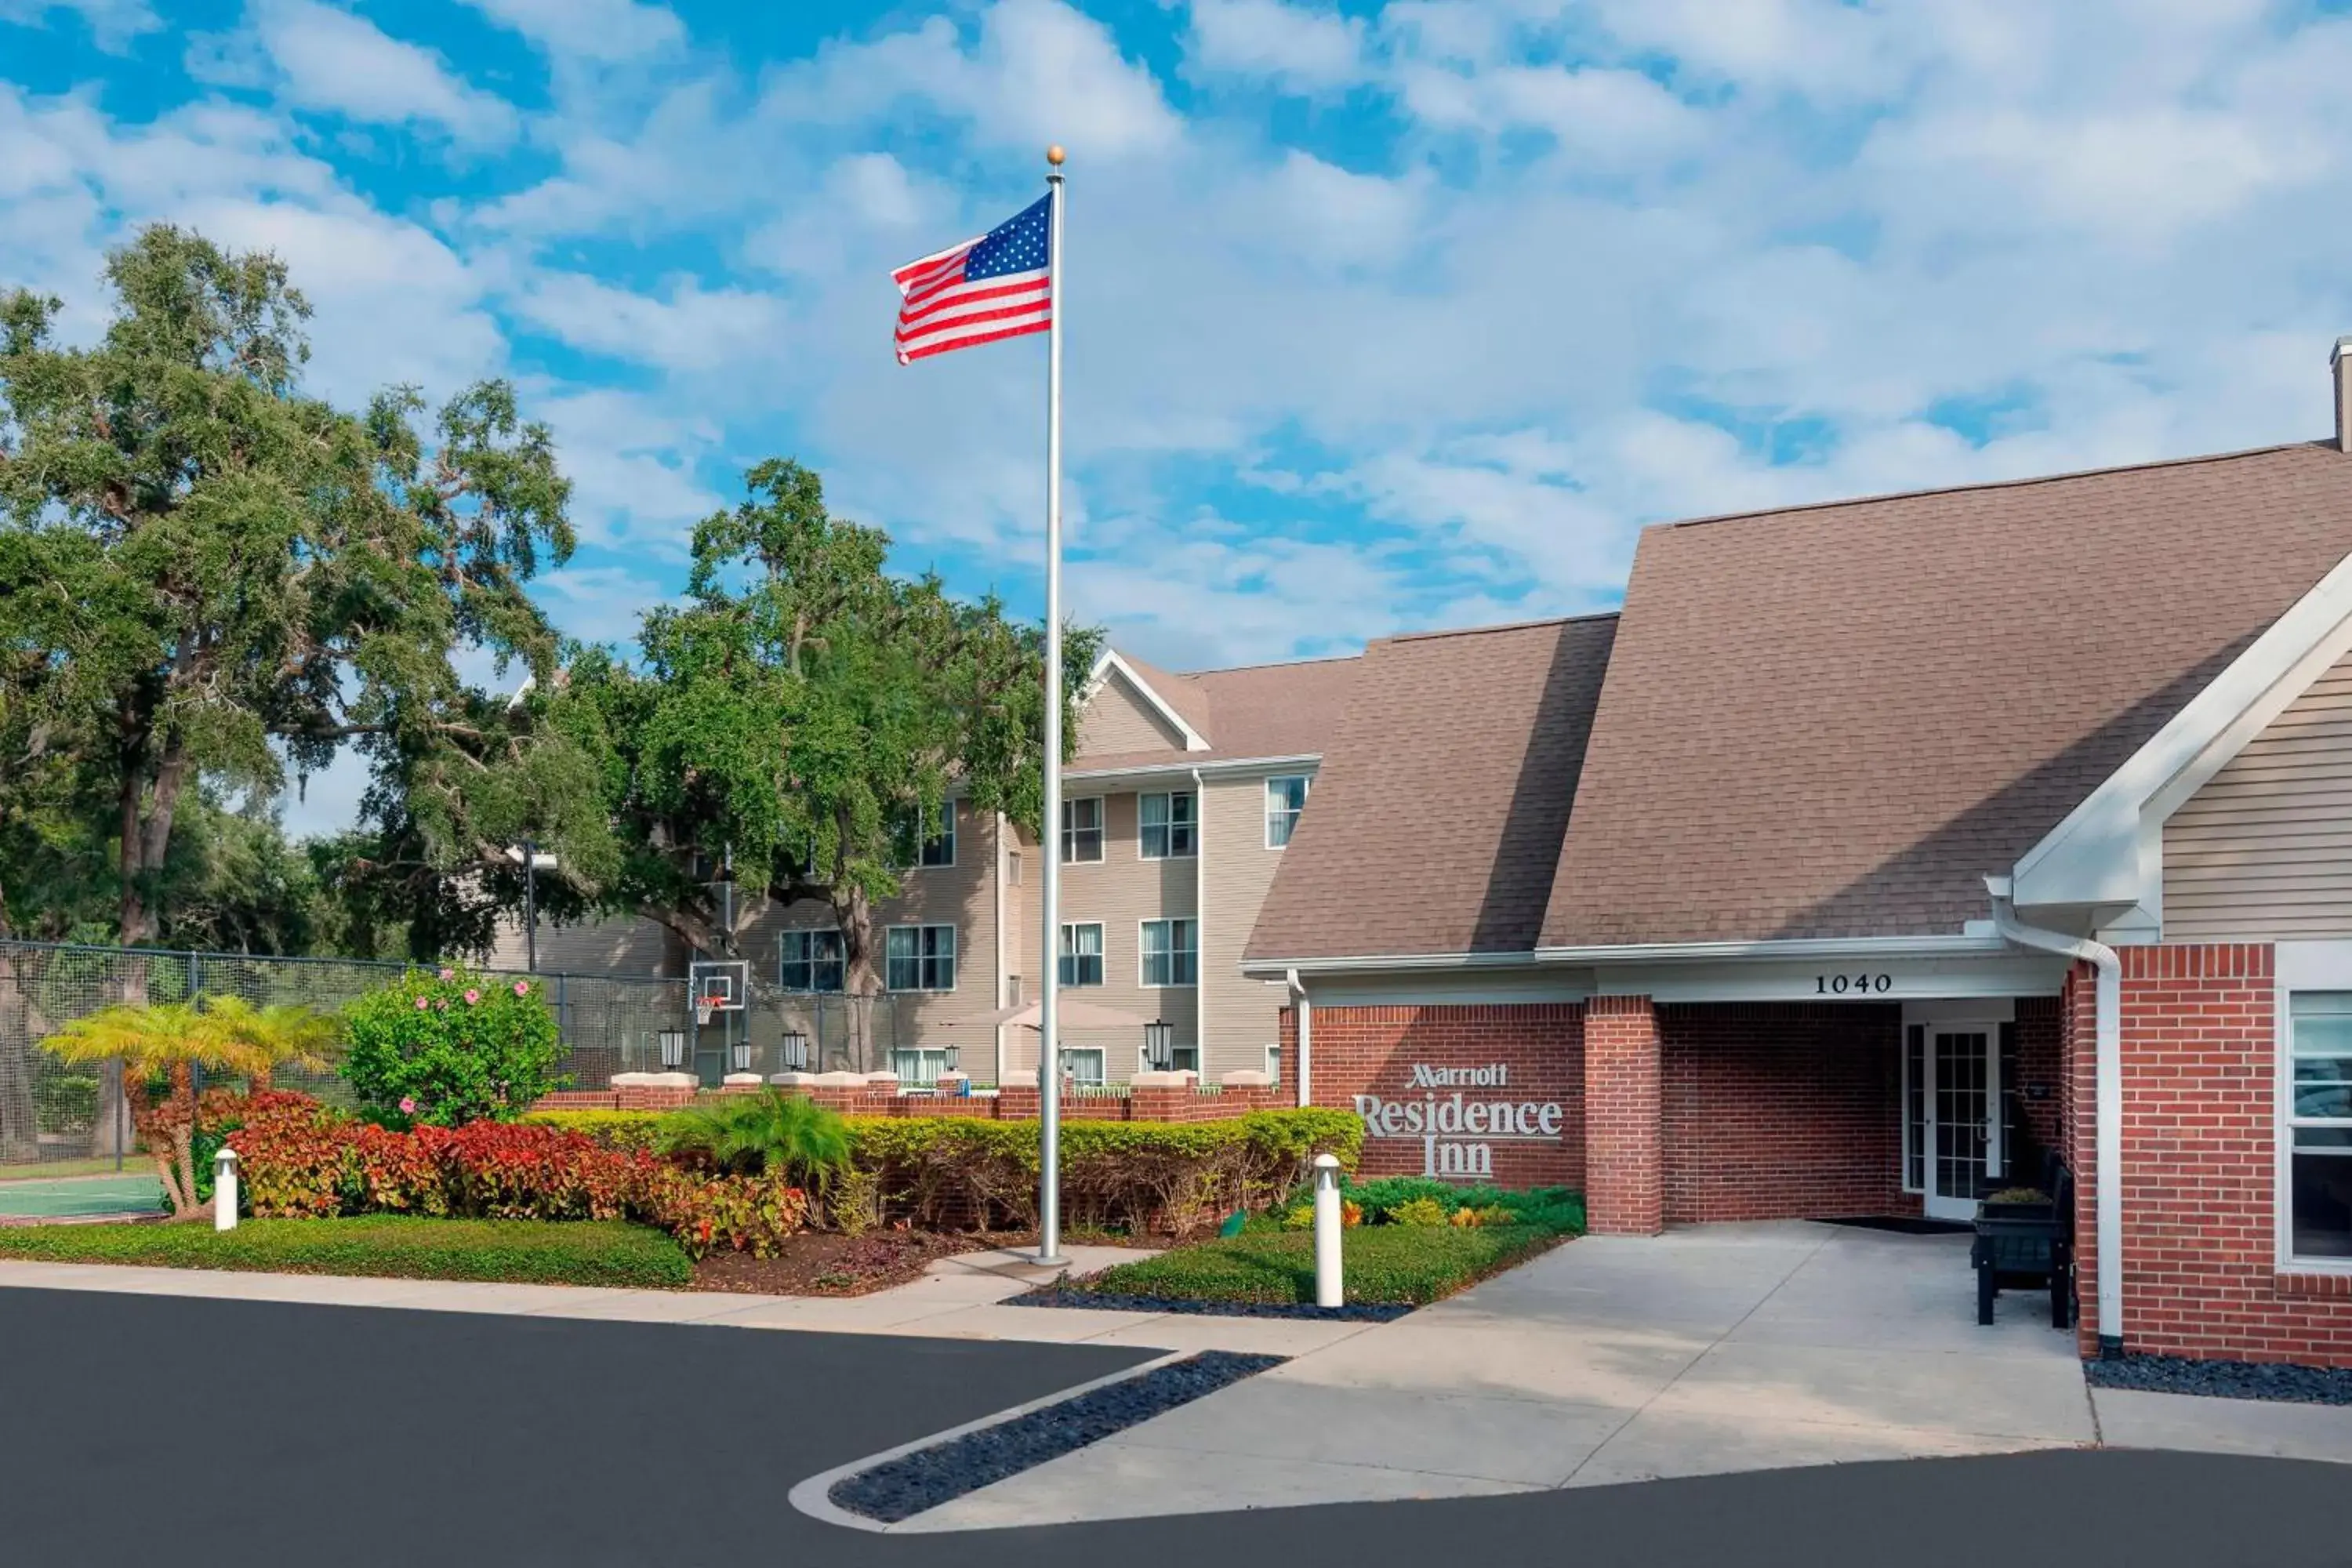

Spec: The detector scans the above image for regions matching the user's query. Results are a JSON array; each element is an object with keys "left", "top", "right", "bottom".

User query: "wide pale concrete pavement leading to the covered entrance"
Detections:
[{"left": 898, "top": 1225, "right": 2352, "bottom": 1530}]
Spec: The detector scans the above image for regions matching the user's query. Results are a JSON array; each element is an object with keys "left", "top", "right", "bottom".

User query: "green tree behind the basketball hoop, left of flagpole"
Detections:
[{"left": 564, "top": 459, "right": 1101, "bottom": 1053}]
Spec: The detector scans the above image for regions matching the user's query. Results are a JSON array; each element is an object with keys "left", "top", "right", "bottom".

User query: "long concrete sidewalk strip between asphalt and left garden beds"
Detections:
[{"left": 0, "top": 1246, "right": 1367, "bottom": 1356}]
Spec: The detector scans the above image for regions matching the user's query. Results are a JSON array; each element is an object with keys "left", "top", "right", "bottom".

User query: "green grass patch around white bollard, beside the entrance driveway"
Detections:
[{"left": 1073, "top": 1225, "right": 1566, "bottom": 1307}]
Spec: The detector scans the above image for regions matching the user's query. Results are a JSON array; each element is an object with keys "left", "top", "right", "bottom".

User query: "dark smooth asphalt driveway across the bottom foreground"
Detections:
[{"left": 0, "top": 1288, "right": 2352, "bottom": 1568}]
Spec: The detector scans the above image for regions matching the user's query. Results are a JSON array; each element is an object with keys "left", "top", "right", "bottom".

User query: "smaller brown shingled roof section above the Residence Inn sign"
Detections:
[{"left": 1247, "top": 616, "right": 1616, "bottom": 959}]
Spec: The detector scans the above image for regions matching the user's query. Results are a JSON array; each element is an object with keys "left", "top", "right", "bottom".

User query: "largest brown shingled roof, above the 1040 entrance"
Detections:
[{"left": 1543, "top": 445, "right": 2352, "bottom": 947}]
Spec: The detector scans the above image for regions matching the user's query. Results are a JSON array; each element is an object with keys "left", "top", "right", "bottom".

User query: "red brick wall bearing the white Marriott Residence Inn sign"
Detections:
[{"left": 1282, "top": 1001, "right": 1585, "bottom": 1189}]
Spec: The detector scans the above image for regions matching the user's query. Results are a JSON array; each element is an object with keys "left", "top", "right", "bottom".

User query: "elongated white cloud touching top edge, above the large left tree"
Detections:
[{"left": 252, "top": 0, "right": 515, "bottom": 141}]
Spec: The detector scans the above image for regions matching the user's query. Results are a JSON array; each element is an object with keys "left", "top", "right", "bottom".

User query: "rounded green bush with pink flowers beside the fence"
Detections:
[{"left": 343, "top": 966, "right": 562, "bottom": 1126}]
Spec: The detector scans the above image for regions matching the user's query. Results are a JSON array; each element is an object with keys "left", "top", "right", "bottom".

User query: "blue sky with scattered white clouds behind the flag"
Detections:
[{"left": 13, "top": 0, "right": 2352, "bottom": 827}]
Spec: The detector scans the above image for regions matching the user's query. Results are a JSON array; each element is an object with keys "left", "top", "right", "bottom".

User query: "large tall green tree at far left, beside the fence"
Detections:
[{"left": 0, "top": 226, "right": 593, "bottom": 945}]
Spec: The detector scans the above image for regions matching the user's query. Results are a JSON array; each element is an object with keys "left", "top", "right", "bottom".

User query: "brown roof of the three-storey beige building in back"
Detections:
[{"left": 1070, "top": 654, "right": 1362, "bottom": 774}]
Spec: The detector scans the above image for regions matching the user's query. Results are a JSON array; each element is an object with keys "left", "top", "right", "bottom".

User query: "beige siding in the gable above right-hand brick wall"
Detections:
[{"left": 2164, "top": 656, "right": 2352, "bottom": 942}]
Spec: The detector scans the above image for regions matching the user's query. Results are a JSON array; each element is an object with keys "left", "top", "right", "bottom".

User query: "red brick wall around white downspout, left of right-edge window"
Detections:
[{"left": 2067, "top": 942, "right": 2352, "bottom": 1366}]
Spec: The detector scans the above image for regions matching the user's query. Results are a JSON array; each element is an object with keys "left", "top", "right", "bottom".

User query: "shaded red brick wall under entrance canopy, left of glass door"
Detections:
[{"left": 1656, "top": 1001, "right": 1919, "bottom": 1225}]
